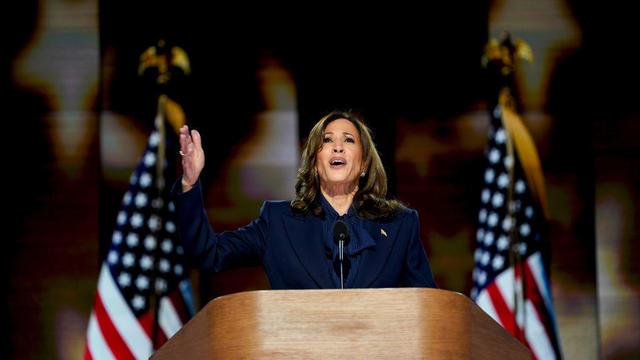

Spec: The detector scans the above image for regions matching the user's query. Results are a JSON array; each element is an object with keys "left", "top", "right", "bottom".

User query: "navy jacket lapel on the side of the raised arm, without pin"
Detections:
[{"left": 283, "top": 214, "right": 334, "bottom": 289}]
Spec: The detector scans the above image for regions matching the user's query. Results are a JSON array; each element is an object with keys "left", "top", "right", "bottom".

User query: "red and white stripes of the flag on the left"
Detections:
[{"left": 85, "top": 264, "right": 185, "bottom": 359}]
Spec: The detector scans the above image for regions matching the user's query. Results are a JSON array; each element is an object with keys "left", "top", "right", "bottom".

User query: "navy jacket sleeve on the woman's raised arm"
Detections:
[{"left": 172, "top": 180, "right": 268, "bottom": 272}]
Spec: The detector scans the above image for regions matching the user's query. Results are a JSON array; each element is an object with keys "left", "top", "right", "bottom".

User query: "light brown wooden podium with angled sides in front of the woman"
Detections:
[{"left": 152, "top": 288, "right": 531, "bottom": 360}]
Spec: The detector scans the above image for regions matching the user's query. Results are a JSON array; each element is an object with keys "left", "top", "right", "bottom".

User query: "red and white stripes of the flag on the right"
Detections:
[{"left": 476, "top": 253, "right": 557, "bottom": 360}]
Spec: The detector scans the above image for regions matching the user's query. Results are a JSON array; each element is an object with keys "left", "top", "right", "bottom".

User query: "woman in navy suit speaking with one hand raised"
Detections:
[{"left": 174, "top": 112, "right": 436, "bottom": 289}]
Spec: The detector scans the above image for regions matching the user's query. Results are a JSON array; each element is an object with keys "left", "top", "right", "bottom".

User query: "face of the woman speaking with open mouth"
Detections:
[{"left": 316, "top": 119, "right": 363, "bottom": 191}]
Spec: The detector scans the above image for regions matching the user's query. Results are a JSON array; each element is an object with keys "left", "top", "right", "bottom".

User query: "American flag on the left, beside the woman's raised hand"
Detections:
[{"left": 84, "top": 116, "right": 194, "bottom": 359}]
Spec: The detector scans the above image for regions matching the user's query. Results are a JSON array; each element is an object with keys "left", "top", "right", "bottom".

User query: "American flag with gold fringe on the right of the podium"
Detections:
[{"left": 471, "top": 105, "right": 562, "bottom": 359}]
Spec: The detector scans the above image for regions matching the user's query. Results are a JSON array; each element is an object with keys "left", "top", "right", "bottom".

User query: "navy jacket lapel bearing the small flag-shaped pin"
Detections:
[{"left": 353, "top": 221, "right": 397, "bottom": 288}]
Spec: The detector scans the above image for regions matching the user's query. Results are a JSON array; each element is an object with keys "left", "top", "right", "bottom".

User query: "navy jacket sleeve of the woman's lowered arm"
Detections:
[{"left": 401, "top": 210, "right": 438, "bottom": 288}]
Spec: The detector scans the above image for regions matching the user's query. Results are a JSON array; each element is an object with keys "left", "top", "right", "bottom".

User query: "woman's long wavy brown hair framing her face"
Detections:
[{"left": 290, "top": 111, "right": 403, "bottom": 219}]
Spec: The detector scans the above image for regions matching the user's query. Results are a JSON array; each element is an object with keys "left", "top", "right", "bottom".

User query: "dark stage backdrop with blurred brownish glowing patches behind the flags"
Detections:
[{"left": 3, "top": 0, "right": 640, "bottom": 359}]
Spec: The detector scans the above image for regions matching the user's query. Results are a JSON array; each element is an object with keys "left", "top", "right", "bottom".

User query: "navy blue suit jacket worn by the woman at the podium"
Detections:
[{"left": 174, "top": 182, "right": 437, "bottom": 289}]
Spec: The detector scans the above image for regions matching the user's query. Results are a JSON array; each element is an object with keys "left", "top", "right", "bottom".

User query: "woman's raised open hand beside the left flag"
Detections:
[{"left": 180, "top": 125, "right": 204, "bottom": 192}]
